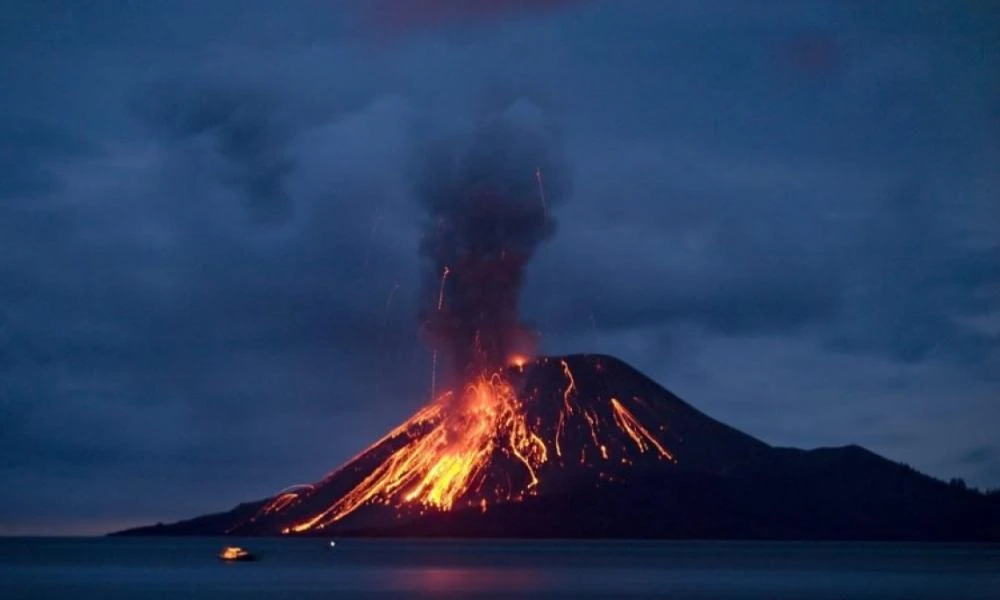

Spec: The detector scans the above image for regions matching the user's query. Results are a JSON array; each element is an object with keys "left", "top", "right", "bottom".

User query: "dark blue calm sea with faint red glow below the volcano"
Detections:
[{"left": 0, "top": 538, "right": 1000, "bottom": 600}]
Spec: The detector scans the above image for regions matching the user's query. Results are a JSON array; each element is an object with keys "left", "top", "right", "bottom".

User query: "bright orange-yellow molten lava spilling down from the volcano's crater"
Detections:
[{"left": 255, "top": 359, "right": 676, "bottom": 533}]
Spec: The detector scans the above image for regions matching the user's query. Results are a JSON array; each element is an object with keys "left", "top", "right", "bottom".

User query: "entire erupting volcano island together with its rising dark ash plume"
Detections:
[{"left": 119, "top": 103, "right": 1000, "bottom": 539}]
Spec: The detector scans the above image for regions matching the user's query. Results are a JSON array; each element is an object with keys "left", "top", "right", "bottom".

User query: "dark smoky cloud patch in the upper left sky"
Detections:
[{"left": 133, "top": 82, "right": 294, "bottom": 224}]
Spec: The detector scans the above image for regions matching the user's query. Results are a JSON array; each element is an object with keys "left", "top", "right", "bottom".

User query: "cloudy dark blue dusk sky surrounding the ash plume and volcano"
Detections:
[{"left": 0, "top": 0, "right": 1000, "bottom": 535}]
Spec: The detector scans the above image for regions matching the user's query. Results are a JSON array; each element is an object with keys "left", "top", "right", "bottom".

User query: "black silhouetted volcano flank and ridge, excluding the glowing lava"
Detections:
[{"left": 115, "top": 355, "right": 1000, "bottom": 541}]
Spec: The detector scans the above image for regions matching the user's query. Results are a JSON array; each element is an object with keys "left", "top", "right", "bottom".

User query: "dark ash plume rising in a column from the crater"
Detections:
[{"left": 417, "top": 100, "right": 568, "bottom": 378}]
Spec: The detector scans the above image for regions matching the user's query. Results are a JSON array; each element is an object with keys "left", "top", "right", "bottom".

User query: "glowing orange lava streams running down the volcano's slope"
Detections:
[{"left": 280, "top": 370, "right": 676, "bottom": 533}]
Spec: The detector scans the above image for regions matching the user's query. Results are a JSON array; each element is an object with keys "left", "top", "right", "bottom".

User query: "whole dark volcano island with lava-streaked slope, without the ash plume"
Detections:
[{"left": 113, "top": 355, "right": 1000, "bottom": 540}]
